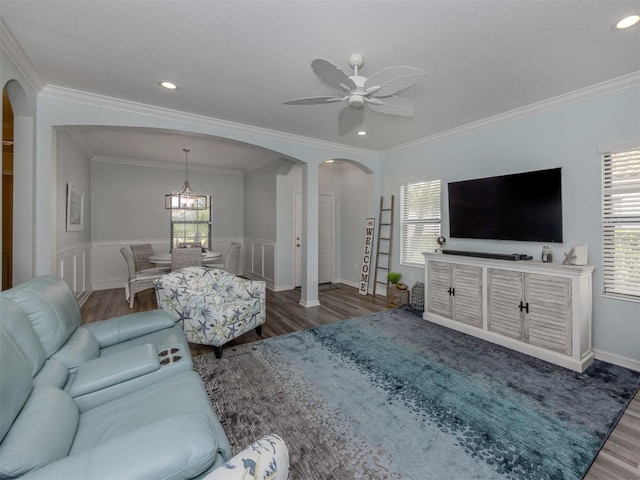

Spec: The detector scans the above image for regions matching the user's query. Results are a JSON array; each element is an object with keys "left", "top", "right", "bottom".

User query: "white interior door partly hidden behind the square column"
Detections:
[{"left": 294, "top": 193, "right": 333, "bottom": 287}]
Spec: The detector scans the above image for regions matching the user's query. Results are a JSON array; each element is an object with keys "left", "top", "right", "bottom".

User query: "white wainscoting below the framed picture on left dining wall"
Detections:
[{"left": 56, "top": 244, "right": 93, "bottom": 305}]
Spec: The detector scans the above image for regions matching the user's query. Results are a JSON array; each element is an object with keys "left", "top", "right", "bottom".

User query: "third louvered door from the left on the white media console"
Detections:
[{"left": 487, "top": 268, "right": 525, "bottom": 341}]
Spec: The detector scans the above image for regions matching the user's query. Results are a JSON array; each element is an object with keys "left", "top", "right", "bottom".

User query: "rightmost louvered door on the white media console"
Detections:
[{"left": 525, "top": 274, "right": 572, "bottom": 355}]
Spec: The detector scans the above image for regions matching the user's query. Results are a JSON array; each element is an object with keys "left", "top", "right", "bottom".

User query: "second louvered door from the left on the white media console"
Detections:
[{"left": 452, "top": 265, "right": 482, "bottom": 327}]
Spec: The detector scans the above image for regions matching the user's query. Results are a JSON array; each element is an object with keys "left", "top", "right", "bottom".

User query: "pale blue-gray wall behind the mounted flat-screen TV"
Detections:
[{"left": 381, "top": 88, "right": 640, "bottom": 361}]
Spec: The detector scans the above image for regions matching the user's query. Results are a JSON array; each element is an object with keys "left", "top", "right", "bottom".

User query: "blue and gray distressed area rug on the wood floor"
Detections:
[{"left": 194, "top": 308, "right": 640, "bottom": 480}]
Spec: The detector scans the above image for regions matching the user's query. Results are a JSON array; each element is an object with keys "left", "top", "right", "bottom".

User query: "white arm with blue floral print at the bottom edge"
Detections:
[{"left": 203, "top": 434, "right": 289, "bottom": 480}]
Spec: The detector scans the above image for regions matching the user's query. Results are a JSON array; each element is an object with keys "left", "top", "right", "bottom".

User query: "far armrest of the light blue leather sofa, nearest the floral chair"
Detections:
[{"left": 83, "top": 309, "right": 175, "bottom": 348}]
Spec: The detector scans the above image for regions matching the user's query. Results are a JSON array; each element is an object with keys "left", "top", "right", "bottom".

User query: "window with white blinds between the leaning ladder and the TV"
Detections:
[{"left": 400, "top": 180, "right": 440, "bottom": 265}]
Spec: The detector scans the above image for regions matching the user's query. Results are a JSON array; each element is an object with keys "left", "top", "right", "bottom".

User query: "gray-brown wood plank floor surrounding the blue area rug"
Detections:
[{"left": 81, "top": 284, "right": 640, "bottom": 480}]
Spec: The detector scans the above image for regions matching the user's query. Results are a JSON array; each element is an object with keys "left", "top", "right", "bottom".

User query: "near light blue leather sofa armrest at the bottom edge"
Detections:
[{"left": 21, "top": 414, "right": 218, "bottom": 480}]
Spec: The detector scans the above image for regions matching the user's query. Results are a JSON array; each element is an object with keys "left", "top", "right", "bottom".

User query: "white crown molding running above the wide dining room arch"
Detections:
[{"left": 40, "top": 85, "right": 379, "bottom": 157}]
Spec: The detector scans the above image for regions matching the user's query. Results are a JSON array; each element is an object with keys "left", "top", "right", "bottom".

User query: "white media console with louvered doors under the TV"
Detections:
[{"left": 423, "top": 253, "right": 594, "bottom": 372}]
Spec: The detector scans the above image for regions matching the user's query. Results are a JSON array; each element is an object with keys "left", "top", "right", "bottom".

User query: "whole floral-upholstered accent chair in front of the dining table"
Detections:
[{"left": 154, "top": 267, "right": 266, "bottom": 358}]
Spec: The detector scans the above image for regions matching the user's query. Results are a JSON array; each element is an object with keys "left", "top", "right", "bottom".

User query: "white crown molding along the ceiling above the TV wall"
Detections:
[{"left": 380, "top": 71, "right": 640, "bottom": 155}]
